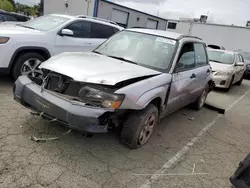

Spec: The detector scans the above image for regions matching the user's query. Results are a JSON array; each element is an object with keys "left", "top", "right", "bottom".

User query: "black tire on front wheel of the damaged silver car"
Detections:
[{"left": 121, "top": 104, "right": 158, "bottom": 149}]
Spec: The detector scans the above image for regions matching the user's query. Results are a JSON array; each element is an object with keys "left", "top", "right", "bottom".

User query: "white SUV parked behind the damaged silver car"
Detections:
[{"left": 0, "top": 14, "right": 123, "bottom": 79}]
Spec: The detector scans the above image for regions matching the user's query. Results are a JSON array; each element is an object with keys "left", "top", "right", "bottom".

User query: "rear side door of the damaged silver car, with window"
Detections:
[{"left": 191, "top": 43, "right": 211, "bottom": 101}]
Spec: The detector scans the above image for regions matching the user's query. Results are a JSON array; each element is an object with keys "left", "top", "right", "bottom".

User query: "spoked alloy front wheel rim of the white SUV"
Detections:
[{"left": 21, "top": 58, "right": 43, "bottom": 78}]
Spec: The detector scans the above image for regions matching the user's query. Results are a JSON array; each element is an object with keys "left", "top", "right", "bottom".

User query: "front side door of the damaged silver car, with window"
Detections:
[{"left": 165, "top": 42, "right": 197, "bottom": 114}]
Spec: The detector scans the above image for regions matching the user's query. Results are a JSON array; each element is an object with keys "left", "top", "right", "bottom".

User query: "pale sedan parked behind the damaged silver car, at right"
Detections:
[{"left": 208, "top": 49, "right": 245, "bottom": 91}]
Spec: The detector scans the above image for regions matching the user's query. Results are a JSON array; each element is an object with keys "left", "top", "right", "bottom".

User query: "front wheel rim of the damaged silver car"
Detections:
[{"left": 138, "top": 114, "right": 156, "bottom": 145}]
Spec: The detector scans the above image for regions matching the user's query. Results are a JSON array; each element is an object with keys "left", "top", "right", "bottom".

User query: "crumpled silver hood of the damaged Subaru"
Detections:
[{"left": 39, "top": 52, "right": 160, "bottom": 85}]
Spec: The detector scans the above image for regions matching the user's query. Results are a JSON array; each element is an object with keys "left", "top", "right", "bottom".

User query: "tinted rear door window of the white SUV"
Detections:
[{"left": 91, "top": 23, "right": 114, "bottom": 39}]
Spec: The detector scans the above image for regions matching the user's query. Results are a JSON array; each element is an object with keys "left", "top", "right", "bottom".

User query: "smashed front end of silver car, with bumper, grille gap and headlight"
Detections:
[{"left": 13, "top": 71, "right": 158, "bottom": 133}]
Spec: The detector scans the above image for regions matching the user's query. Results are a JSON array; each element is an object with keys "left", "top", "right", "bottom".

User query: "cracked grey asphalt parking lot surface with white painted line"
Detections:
[{"left": 0, "top": 77, "right": 250, "bottom": 188}]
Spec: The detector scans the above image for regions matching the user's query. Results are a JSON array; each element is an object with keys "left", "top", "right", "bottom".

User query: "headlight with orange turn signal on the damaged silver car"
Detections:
[{"left": 79, "top": 86, "right": 125, "bottom": 109}]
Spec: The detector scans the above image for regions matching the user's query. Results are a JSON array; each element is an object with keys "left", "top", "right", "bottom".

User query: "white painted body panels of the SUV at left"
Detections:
[{"left": 0, "top": 14, "right": 123, "bottom": 71}]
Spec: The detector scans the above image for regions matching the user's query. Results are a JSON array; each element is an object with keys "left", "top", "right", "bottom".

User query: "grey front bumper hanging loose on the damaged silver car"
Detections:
[{"left": 13, "top": 76, "right": 114, "bottom": 133}]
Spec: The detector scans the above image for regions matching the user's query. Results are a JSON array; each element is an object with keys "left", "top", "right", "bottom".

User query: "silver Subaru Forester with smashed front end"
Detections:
[{"left": 13, "top": 28, "right": 214, "bottom": 148}]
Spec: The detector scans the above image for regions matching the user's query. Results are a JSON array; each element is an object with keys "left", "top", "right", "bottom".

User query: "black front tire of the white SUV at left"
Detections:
[{"left": 12, "top": 52, "right": 46, "bottom": 80}]
